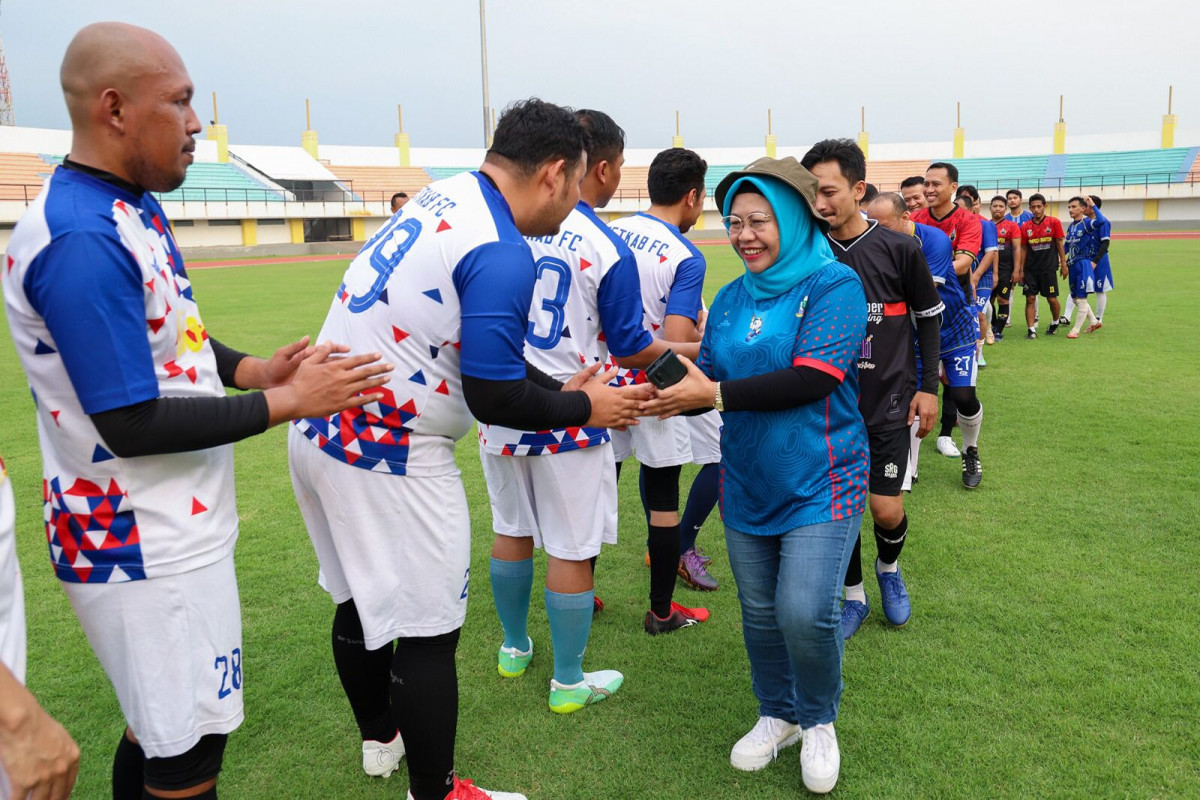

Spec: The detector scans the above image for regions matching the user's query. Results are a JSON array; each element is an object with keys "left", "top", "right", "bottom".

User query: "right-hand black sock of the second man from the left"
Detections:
[{"left": 391, "top": 628, "right": 462, "bottom": 800}]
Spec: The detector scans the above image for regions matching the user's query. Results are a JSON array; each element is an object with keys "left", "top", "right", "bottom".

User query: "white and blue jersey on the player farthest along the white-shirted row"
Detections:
[{"left": 610, "top": 212, "right": 706, "bottom": 376}]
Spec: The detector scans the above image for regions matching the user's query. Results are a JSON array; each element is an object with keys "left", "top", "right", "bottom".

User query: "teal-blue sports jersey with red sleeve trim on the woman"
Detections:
[{"left": 697, "top": 264, "right": 868, "bottom": 536}]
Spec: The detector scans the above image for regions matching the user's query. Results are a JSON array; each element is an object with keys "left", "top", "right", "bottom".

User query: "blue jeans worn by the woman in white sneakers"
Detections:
[{"left": 725, "top": 515, "right": 863, "bottom": 728}]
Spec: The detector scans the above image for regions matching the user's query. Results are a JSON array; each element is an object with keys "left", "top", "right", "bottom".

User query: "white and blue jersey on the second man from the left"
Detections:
[{"left": 296, "top": 172, "right": 534, "bottom": 477}]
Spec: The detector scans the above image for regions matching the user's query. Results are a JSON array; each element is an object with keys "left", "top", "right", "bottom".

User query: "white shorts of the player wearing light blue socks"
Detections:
[{"left": 479, "top": 444, "right": 617, "bottom": 561}]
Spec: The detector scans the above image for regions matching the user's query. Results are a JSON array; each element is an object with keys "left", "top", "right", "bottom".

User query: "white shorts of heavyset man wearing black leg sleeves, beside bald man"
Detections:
[{"left": 288, "top": 426, "right": 470, "bottom": 650}]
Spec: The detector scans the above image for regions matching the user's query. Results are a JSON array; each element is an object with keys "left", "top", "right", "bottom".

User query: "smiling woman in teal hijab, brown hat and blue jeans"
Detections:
[{"left": 644, "top": 158, "right": 870, "bottom": 793}]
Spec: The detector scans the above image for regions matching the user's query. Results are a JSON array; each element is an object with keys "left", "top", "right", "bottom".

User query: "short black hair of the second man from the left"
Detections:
[{"left": 487, "top": 97, "right": 590, "bottom": 175}]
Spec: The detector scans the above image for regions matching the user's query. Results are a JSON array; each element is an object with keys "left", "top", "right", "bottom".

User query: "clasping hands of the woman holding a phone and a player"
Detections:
[{"left": 563, "top": 350, "right": 716, "bottom": 429}]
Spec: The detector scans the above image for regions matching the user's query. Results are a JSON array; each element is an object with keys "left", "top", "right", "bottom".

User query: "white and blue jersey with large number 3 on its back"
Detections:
[{"left": 472, "top": 203, "right": 652, "bottom": 456}]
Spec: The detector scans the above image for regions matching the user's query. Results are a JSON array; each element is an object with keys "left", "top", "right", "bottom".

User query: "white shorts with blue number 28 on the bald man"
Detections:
[{"left": 62, "top": 553, "right": 244, "bottom": 758}]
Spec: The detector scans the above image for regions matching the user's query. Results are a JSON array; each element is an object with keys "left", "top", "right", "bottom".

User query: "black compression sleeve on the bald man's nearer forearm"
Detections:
[{"left": 91, "top": 392, "right": 270, "bottom": 458}]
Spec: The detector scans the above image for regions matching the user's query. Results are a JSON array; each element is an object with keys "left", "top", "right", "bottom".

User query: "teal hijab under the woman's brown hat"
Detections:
[{"left": 721, "top": 175, "right": 838, "bottom": 300}]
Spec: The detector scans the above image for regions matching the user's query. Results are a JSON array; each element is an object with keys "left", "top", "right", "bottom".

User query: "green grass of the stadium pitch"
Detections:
[{"left": 0, "top": 241, "right": 1200, "bottom": 800}]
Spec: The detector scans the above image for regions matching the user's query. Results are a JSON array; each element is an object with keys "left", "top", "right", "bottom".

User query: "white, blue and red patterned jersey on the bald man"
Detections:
[{"left": 4, "top": 167, "right": 238, "bottom": 583}]
